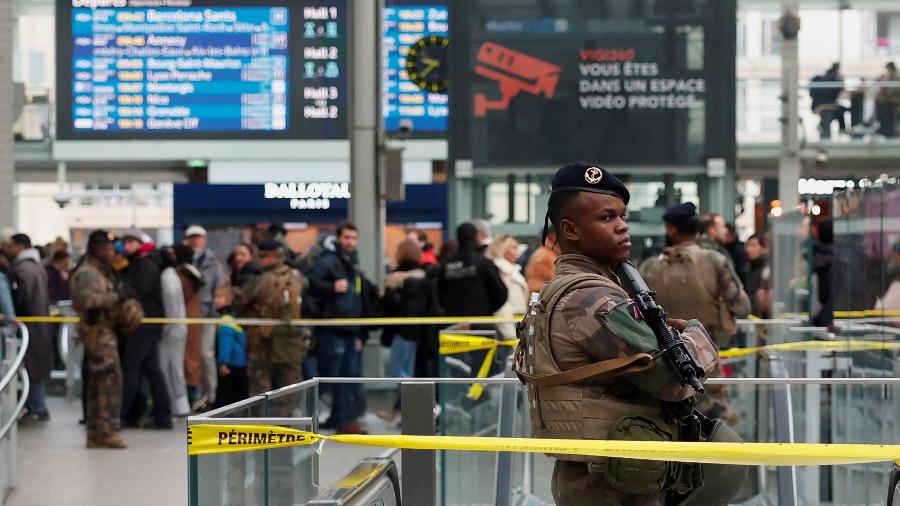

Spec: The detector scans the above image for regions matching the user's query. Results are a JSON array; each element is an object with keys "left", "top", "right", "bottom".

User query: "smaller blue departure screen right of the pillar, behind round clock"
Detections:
[{"left": 383, "top": 4, "right": 450, "bottom": 134}]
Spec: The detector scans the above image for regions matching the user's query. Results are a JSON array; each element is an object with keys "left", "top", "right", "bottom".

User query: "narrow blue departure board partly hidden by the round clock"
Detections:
[{"left": 382, "top": 0, "right": 450, "bottom": 136}]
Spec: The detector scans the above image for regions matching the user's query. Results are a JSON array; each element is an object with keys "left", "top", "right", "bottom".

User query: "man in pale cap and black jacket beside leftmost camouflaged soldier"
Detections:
[{"left": 119, "top": 227, "right": 173, "bottom": 429}]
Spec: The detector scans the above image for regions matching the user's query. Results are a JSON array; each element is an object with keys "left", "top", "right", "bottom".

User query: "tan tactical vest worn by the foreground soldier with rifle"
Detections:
[{"left": 514, "top": 273, "right": 667, "bottom": 462}]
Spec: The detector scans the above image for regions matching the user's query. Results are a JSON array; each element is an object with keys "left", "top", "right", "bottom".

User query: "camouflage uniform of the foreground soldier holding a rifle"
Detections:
[{"left": 533, "top": 254, "right": 718, "bottom": 506}]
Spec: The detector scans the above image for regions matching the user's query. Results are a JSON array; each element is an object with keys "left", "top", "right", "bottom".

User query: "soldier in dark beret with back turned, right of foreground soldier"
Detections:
[{"left": 641, "top": 202, "right": 750, "bottom": 423}]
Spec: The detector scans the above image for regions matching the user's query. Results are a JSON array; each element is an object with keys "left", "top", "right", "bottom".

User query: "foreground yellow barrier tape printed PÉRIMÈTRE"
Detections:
[{"left": 188, "top": 424, "right": 900, "bottom": 466}]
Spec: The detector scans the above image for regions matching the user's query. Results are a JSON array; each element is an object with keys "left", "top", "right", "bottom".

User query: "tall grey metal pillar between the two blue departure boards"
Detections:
[{"left": 348, "top": 0, "right": 386, "bottom": 285}]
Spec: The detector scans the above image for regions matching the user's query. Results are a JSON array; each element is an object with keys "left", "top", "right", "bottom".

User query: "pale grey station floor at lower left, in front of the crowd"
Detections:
[{"left": 7, "top": 397, "right": 399, "bottom": 506}]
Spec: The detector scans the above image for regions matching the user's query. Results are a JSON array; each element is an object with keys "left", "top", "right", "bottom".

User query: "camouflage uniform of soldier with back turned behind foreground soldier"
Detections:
[{"left": 641, "top": 241, "right": 750, "bottom": 424}]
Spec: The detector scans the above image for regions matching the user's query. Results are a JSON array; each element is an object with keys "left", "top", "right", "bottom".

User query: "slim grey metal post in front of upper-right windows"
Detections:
[{"left": 778, "top": 0, "right": 800, "bottom": 213}]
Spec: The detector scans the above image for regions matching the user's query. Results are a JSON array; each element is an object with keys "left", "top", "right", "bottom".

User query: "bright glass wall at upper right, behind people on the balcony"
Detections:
[{"left": 737, "top": 0, "right": 900, "bottom": 144}]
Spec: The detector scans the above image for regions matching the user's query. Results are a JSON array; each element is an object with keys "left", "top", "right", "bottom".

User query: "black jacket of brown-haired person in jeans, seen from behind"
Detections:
[{"left": 381, "top": 262, "right": 438, "bottom": 346}]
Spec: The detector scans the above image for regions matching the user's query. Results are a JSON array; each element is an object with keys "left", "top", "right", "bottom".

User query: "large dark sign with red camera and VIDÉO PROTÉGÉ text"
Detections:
[{"left": 451, "top": 0, "right": 734, "bottom": 168}]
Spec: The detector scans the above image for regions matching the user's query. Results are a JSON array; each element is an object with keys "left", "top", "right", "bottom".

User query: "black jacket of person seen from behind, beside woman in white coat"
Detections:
[{"left": 437, "top": 245, "right": 508, "bottom": 316}]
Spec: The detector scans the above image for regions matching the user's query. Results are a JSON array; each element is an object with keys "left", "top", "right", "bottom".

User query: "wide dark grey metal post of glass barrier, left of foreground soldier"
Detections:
[{"left": 400, "top": 383, "right": 437, "bottom": 506}]
